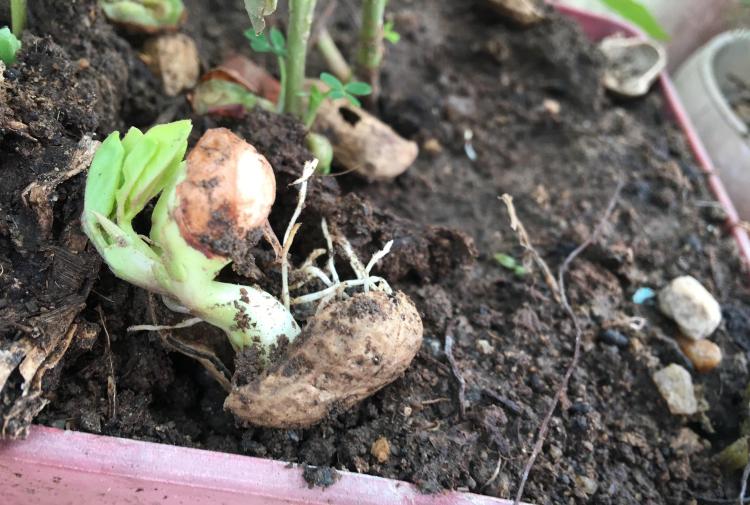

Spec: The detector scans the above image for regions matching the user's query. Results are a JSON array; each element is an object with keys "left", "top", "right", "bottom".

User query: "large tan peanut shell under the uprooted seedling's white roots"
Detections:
[{"left": 224, "top": 291, "right": 422, "bottom": 428}]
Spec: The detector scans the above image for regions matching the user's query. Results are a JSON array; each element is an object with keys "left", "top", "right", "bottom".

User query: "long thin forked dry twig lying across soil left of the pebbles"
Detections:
[{"left": 503, "top": 181, "right": 623, "bottom": 505}]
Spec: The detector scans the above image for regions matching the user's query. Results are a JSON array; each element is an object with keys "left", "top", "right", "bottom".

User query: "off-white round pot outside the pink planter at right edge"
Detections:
[{"left": 675, "top": 31, "right": 750, "bottom": 221}]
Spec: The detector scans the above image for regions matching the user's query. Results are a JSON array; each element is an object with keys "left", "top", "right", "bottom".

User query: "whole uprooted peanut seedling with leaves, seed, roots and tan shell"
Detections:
[{"left": 82, "top": 121, "right": 422, "bottom": 427}]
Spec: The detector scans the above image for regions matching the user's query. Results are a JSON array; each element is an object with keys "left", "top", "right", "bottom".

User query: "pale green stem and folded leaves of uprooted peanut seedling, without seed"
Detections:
[{"left": 82, "top": 121, "right": 300, "bottom": 349}]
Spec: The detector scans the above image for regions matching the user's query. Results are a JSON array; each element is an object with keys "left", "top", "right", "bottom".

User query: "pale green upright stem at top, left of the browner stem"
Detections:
[{"left": 284, "top": 0, "right": 316, "bottom": 118}]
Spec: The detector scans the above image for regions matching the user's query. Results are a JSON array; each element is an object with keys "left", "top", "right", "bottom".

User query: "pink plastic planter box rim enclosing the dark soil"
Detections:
[{"left": 0, "top": 7, "right": 750, "bottom": 505}]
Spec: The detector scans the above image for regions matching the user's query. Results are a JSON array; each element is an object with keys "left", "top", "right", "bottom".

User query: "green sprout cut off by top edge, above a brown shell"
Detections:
[{"left": 99, "top": 0, "right": 185, "bottom": 33}]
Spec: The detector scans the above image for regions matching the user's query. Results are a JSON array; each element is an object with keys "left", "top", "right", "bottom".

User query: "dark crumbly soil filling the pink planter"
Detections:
[{"left": 0, "top": 0, "right": 750, "bottom": 504}]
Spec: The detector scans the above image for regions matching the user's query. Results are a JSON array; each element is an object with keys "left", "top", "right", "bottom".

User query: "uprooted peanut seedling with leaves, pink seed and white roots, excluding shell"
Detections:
[{"left": 81, "top": 120, "right": 393, "bottom": 357}]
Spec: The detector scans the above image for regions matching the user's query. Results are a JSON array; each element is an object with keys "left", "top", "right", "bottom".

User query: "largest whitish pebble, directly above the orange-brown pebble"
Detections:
[{"left": 659, "top": 275, "right": 721, "bottom": 340}]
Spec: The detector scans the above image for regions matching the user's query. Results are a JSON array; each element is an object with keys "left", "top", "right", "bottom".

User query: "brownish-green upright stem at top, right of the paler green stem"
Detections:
[{"left": 357, "top": 0, "right": 388, "bottom": 104}]
